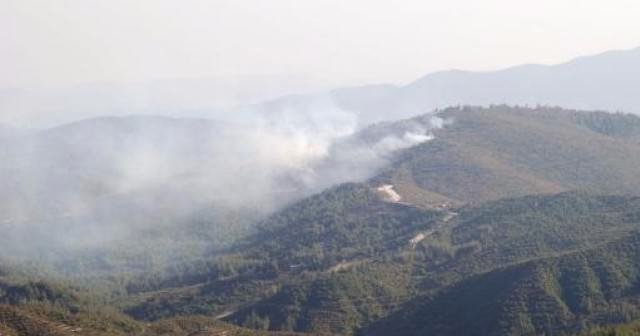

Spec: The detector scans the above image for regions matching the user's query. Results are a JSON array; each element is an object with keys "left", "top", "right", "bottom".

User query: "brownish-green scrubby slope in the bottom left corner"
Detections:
[{"left": 0, "top": 280, "right": 314, "bottom": 336}]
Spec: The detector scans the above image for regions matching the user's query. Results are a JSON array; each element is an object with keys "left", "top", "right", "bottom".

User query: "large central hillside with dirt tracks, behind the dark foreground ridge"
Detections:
[{"left": 120, "top": 106, "right": 640, "bottom": 334}]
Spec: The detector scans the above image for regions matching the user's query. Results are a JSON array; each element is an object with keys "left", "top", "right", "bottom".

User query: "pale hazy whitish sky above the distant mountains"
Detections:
[{"left": 0, "top": 0, "right": 640, "bottom": 88}]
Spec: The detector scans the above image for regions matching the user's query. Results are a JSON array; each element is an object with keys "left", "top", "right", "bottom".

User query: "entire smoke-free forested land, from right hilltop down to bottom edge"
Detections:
[{"left": 0, "top": 106, "right": 640, "bottom": 336}]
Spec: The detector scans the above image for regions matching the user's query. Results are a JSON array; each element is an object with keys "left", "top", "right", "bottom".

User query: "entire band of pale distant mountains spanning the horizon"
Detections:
[{"left": 0, "top": 48, "right": 640, "bottom": 127}]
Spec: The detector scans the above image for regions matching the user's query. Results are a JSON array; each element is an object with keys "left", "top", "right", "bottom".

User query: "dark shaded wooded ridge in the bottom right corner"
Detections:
[{"left": 364, "top": 233, "right": 640, "bottom": 335}]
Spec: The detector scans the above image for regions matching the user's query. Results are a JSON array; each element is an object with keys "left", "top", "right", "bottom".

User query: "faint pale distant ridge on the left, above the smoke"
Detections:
[{"left": 0, "top": 75, "right": 330, "bottom": 128}]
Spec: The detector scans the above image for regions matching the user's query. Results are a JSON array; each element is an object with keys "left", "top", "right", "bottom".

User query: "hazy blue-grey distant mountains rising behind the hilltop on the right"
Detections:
[{"left": 258, "top": 48, "right": 640, "bottom": 124}]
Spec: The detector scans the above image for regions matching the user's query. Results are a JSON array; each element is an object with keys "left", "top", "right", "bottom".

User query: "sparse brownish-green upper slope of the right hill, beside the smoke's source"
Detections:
[{"left": 380, "top": 106, "right": 640, "bottom": 203}]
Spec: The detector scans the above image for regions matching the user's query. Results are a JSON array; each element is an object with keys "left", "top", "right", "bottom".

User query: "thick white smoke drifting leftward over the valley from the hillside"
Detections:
[{"left": 0, "top": 99, "right": 445, "bottom": 272}]
